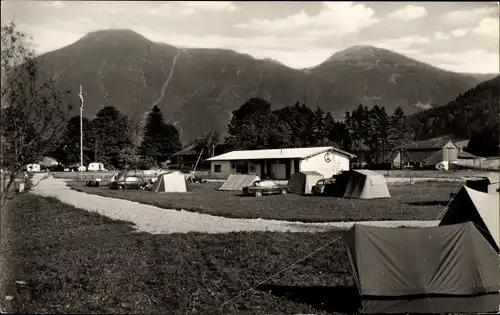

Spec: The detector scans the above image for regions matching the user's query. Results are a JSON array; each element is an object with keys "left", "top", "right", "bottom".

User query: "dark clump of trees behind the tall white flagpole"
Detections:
[{"left": 50, "top": 105, "right": 182, "bottom": 169}]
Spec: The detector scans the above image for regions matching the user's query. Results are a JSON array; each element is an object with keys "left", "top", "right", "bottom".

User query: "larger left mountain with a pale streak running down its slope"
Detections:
[{"left": 37, "top": 30, "right": 352, "bottom": 141}]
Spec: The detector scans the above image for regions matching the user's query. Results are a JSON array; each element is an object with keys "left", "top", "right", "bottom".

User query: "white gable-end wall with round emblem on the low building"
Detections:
[{"left": 300, "top": 151, "right": 349, "bottom": 178}]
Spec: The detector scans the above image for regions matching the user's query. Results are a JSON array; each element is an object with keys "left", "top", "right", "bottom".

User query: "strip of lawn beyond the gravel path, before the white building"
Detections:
[{"left": 67, "top": 181, "right": 458, "bottom": 222}]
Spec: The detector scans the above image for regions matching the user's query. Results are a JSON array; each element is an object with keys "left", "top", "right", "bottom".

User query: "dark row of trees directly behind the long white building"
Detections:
[{"left": 225, "top": 98, "right": 413, "bottom": 164}]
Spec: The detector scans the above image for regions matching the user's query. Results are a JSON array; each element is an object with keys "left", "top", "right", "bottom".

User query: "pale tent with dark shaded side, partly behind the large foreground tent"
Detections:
[{"left": 439, "top": 186, "right": 500, "bottom": 252}]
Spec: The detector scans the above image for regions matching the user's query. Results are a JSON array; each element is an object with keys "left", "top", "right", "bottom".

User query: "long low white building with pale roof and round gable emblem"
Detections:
[{"left": 207, "top": 147, "right": 355, "bottom": 180}]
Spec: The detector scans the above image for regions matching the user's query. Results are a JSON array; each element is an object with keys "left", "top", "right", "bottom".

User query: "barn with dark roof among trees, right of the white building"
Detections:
[{"left": 393, "top": 138, "right": 459, "bottom": 169}]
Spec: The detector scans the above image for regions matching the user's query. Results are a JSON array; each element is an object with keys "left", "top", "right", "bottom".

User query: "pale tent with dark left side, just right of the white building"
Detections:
[{"left": 334, "top": 170, "right": 391, "bottom": 199}]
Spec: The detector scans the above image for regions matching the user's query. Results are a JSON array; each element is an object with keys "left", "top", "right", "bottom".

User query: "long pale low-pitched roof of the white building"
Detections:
[{"left": 207, "top": 147, "right": 355, "bottom": 161}]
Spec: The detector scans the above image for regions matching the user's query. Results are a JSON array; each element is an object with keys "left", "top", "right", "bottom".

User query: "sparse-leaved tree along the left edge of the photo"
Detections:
[{"left": 0, "top": 23, "right": 69, "bottom": 208}]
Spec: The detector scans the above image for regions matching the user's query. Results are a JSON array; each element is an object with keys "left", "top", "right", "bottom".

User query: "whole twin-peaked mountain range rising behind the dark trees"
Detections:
[{"left": 40, "top": 30, "right": 484, "bottom": 142}]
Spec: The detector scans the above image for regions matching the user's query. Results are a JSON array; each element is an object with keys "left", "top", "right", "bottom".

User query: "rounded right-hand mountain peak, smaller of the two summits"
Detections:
[{"left": 308, "top": 46, "right": 479, "bottom": 113}]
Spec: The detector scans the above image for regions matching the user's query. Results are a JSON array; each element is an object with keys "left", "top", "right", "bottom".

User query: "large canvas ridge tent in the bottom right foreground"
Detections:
[{"left": 343, "top": 222, "right": 500, "bottom": 314}]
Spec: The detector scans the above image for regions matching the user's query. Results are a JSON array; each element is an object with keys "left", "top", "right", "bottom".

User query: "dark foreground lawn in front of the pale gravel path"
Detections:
[{"left": 0, "top": 194, "right": 359, "bottom": 314}]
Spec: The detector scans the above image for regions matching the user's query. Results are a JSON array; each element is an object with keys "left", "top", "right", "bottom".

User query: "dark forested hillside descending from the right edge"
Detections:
[{"left": 409, "top": 76, "right": 500, "bottom": 154}]
